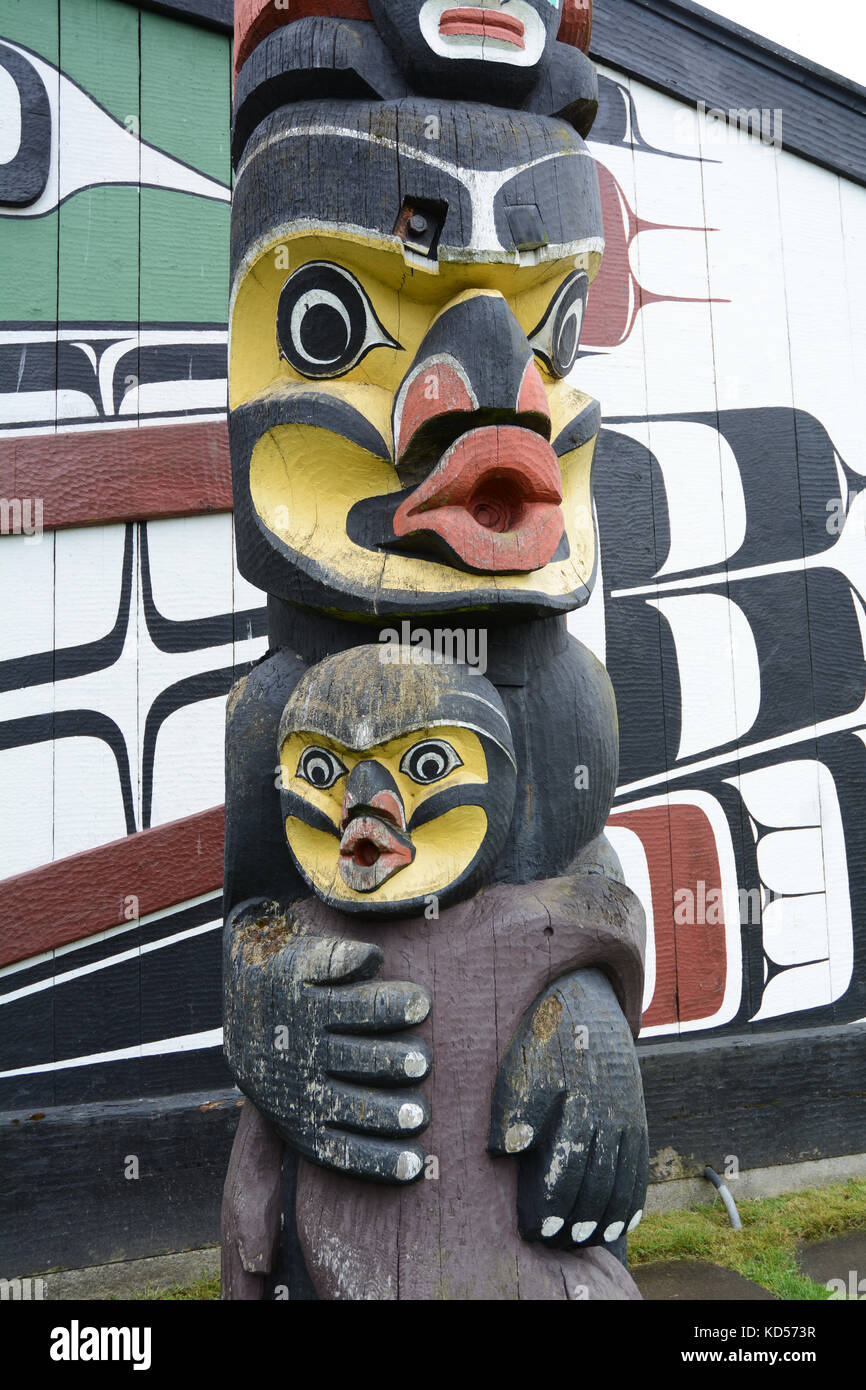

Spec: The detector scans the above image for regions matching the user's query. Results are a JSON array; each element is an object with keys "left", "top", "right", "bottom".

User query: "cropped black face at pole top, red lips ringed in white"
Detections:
[{"left": 370, "top": 0, "right": 563, "bottom": 101}]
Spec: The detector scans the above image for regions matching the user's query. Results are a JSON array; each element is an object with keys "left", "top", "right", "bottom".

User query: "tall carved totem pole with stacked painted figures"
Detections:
[{"left": 222, "top": 0, "right": 648, "bottom": 1300}]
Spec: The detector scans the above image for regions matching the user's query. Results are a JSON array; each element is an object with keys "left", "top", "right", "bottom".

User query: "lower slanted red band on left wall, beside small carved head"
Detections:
[{"left": 0, "top": 806, "right": 225, "bottom": 966}]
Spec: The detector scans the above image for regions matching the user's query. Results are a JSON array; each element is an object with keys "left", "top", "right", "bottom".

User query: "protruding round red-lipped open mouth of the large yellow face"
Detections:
[{"left": 393, "top": 425, "right": 564, "bottom": 574}]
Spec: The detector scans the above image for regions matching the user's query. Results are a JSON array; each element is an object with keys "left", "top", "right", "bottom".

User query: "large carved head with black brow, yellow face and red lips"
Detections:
[{"left": 231, "top": 100, "right": 602, "bottom": 616}]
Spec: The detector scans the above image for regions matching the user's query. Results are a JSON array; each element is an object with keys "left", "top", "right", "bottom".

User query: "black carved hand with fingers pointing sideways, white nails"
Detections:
[{"left": 225, "top": 917, "right": 431, "bottom": 1183}]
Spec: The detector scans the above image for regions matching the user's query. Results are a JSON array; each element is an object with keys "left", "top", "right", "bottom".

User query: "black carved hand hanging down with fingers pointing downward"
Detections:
[{"left": 488, "top": 970, "right": 649, "bottom": 1248}]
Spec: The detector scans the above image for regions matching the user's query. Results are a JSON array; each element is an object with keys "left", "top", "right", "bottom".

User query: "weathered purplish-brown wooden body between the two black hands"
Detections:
[{"left": 287, "top": 876, "right": 641, "bottom": 1300}]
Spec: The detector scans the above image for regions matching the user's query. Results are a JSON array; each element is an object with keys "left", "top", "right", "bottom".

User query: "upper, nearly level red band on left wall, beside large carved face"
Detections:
[{"left": 0, "top": 421, "right": 232, "bottom": 531}]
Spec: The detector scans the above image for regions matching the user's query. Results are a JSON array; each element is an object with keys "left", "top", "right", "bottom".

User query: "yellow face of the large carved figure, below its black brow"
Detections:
[{"left": 231, "top": 231, "right": 601, "bottom": 612}]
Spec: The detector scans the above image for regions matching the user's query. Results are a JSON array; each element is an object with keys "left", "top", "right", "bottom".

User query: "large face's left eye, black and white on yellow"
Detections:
[{"left": 277, "top": 261, "right": 399, "bottom": 377}]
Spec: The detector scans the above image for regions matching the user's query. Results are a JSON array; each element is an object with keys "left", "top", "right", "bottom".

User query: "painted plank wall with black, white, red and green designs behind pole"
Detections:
[{"left": 0, "top": 0, "right": 866, "bottom": 1127}]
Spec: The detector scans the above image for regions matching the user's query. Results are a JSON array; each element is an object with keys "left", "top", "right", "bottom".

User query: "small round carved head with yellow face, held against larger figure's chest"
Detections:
[{"left": 279, "top": 645, "right": 516, "bottom": 916}]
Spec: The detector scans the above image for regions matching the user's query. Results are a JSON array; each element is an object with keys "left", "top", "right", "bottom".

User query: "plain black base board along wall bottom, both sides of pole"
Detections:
[{"left": 0, "top": 1024, "right": 866, "bottom": 1279}]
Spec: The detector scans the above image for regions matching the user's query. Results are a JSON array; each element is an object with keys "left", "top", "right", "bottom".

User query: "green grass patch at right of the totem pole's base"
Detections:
[{"left": 628, "top": 1177, "right": 866, "bottom": 1301}]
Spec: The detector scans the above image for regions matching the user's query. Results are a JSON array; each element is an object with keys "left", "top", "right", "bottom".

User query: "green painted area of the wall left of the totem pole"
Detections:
[{"left": 0, "top": 0, "right": 231, "bottom": 339}]
